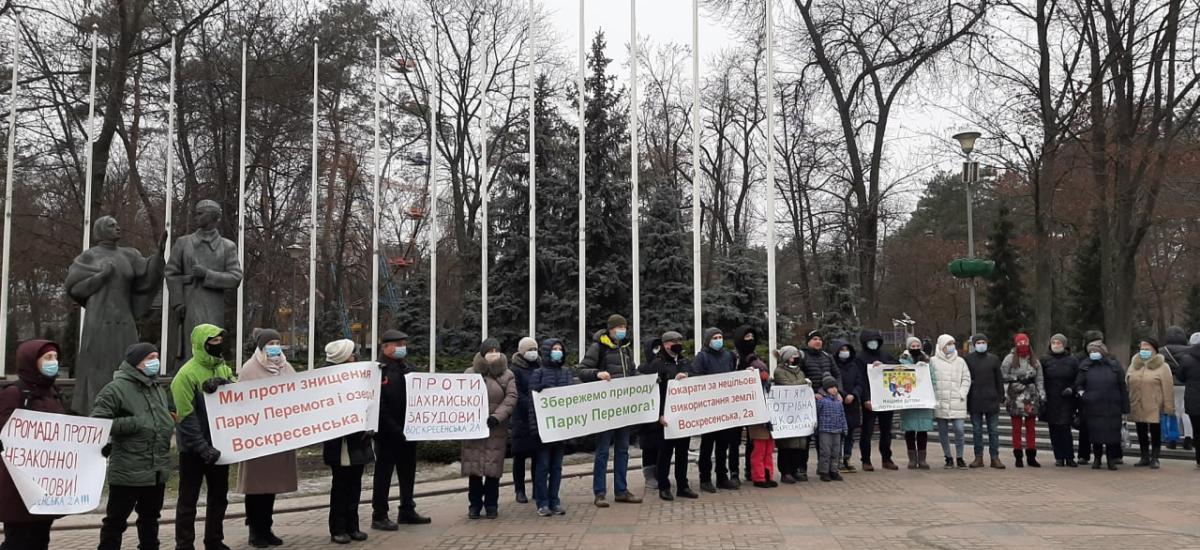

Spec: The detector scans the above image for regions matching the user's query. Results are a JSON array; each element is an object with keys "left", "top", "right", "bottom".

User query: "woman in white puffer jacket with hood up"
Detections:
[{"left": 929, "top": 334, "right": 971, "bottom": 468}]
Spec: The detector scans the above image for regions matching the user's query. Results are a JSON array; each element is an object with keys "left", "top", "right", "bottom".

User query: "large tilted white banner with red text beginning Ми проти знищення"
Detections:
[{"left": 204, "top": 361, "right": 380, "bottom": 465}]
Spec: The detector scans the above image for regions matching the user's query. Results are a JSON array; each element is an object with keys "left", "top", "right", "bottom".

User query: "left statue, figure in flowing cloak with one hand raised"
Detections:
[{"left": 66, "top": 216, "right": 167, "bottom": 414}]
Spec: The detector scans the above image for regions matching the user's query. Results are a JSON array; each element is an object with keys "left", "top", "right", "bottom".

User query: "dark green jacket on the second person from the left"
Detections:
[{"left": 91, "top": 363, "right": 175, "bottom": 486}]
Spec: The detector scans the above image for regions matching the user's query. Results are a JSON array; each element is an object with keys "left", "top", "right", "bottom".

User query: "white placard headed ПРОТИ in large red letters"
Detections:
[{"left": 404, "top": 372, "right": 490, "bottom": 441}]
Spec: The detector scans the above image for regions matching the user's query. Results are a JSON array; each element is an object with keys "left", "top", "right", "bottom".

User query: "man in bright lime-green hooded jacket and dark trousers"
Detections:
[{"left": 170, "top": 324, "right": 234, "bottom": 550}]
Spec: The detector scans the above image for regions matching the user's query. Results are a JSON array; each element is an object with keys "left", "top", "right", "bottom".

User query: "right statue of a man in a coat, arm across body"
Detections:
[{"left": 167, "top": 201, "right": 241, "bottom": 359}]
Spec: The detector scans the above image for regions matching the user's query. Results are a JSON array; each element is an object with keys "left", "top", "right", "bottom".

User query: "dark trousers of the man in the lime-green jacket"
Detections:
[{"left": 175, "top": 453, "right": 229, "bottom": 550}]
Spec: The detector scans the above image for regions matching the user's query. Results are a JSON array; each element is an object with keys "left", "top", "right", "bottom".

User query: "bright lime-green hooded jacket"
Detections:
[{"left": 170, "top": 324, "right": 236, "bottom": 453}]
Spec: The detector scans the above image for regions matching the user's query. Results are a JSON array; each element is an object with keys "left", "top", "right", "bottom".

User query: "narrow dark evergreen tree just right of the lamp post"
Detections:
[{"left": 983, "top": 207, "right": 1028, "bottom": 349}]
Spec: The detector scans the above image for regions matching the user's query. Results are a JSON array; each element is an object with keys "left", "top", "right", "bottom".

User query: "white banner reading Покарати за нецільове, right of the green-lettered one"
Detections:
[{"left": 664, "top": 370, "right": 770, "bottom": 440}]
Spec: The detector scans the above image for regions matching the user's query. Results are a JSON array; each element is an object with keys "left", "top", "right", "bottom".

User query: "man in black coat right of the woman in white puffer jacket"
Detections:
[{"left": 965, "top": 334, "right": 1004, "bottom": 470}]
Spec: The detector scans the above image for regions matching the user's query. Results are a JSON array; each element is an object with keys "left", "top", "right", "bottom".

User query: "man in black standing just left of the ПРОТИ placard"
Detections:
[{"left": 371, "top": 330, "right": 431, "bottom": 531}]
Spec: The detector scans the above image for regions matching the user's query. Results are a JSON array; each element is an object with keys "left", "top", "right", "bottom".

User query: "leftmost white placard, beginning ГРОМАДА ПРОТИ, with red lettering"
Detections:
[{"left": 0, "top": 408, "right": 113, "bottom": 515}]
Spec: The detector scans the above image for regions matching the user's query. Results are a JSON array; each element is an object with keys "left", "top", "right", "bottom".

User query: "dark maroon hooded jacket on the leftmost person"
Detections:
[{"left": 0, "top": 340, "right": 66, "bottom": 524}]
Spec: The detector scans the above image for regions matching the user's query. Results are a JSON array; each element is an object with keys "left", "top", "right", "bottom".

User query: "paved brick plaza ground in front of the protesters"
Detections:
[{"left": 44, "top": 451, "right": 1200, "bottom": 550}]
